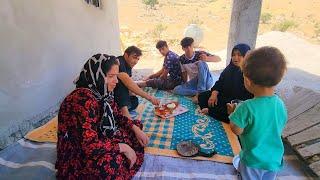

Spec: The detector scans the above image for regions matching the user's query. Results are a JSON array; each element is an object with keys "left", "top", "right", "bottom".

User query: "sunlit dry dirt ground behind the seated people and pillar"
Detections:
[{"left": 118, "top": 0, "right": 320, "bottom": 78}]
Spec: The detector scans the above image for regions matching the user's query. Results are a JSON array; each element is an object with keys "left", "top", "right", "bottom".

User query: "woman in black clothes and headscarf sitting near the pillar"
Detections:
[{"left": 198, "top": 44, "right": 253, "bottom": 123}]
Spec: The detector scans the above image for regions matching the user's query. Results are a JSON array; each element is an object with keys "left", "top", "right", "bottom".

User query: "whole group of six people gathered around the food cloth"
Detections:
[{"left": 56, "top": 37, "right": 286, "bottom": 179}]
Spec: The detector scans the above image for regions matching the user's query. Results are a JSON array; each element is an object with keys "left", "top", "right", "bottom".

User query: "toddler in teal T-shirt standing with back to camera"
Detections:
[{"left": 227, "top": 47, "right": 287, "bottom": 180}]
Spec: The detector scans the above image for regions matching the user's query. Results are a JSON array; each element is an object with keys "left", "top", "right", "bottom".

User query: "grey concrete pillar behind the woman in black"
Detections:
[{"left": 227, "top": 0, "right": 262, "bottom": 65}]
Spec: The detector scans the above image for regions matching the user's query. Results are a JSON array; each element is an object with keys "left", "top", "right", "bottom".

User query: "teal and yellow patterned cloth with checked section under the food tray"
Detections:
[{"left": 140, "top": 89, "right": 240, "bottom": 163}]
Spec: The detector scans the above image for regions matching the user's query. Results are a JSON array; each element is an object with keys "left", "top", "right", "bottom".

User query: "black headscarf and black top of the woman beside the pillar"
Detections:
[{"left": 211, "top": 44, "right": 252, "bottom": 103}]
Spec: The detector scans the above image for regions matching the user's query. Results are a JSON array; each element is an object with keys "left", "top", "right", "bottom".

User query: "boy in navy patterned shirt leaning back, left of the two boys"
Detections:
[{"left": 137, "top": 40, "right": 182, "bottom": 90}]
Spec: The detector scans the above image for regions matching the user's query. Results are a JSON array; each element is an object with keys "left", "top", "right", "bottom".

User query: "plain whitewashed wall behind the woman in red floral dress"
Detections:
[{"left": 0, "top": 0, "right": 120, "bottom": 139}]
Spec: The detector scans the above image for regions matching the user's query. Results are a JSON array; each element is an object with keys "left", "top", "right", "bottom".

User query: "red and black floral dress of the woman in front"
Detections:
[{"left": 56, "top": 88, "right": 144, "bottom": 179}]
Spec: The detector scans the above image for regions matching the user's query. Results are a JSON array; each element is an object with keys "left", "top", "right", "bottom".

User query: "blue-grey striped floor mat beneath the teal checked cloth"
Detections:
[{"left": 0, "top": 139, "right": 316, "bottom": 180}]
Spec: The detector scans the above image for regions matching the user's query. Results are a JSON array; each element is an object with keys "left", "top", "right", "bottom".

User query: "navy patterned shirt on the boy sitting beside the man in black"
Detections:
[{"left": 163, "top": 51, "right": 182, "bottom": 81}]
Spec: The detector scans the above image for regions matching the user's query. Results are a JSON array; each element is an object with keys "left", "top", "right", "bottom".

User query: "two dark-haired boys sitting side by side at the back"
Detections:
[{"left": 138, "top": 37, "right": 220, "bottom": 96}]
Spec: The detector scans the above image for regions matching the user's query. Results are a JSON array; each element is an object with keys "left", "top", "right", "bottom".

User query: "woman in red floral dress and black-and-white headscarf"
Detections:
[{"left": 56, "top": 54, "right": 149, "bottom": 179}]
